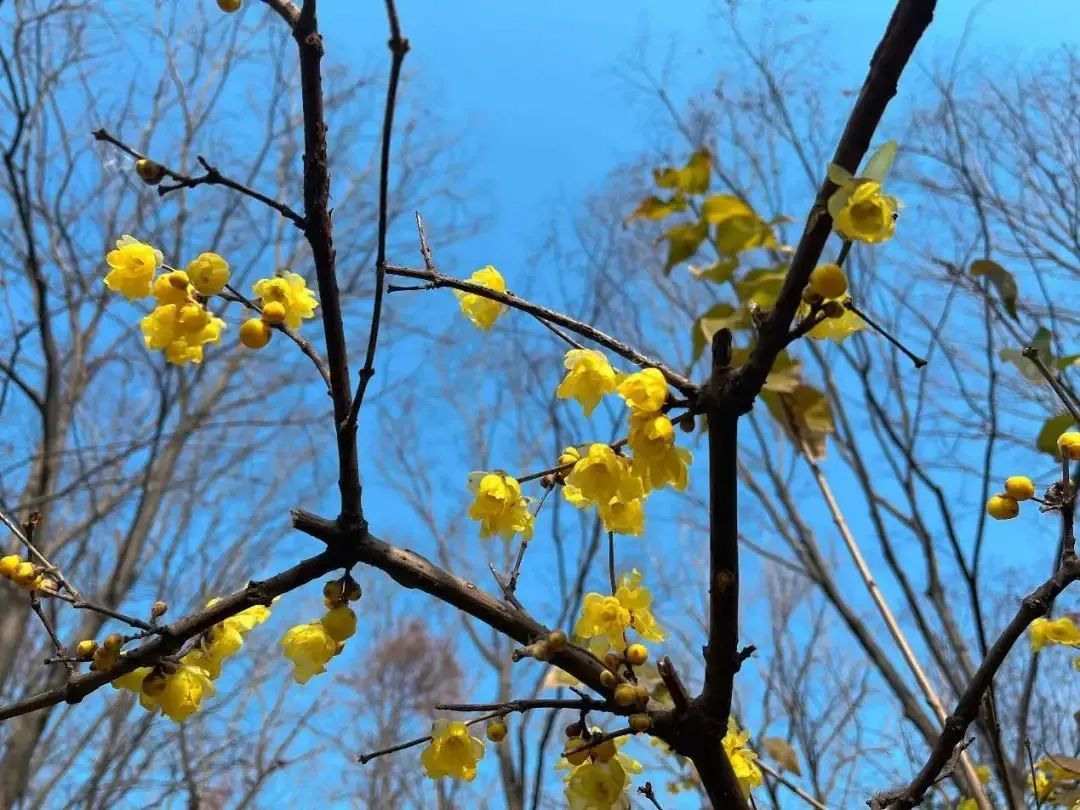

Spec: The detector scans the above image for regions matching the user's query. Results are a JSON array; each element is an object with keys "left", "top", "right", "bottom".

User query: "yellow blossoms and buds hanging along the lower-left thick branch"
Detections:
[{"left": 103, "top": 599, "right": 270, "bottom": 723}]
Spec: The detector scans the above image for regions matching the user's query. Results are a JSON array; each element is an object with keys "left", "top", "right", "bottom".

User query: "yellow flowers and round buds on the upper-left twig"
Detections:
[{"left": 105, "top": 235, "right": 318, "bottom": 365}]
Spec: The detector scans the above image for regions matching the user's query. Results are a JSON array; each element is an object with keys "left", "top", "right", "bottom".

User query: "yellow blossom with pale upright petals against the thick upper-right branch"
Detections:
[{"left": 828, "top": 140, "right": 900, "bottom": 244}]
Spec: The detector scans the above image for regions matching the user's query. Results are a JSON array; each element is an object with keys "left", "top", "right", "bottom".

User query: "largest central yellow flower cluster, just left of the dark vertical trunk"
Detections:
[{"left": 555, "top": 356, "right": 691, "bottom": 535}]
